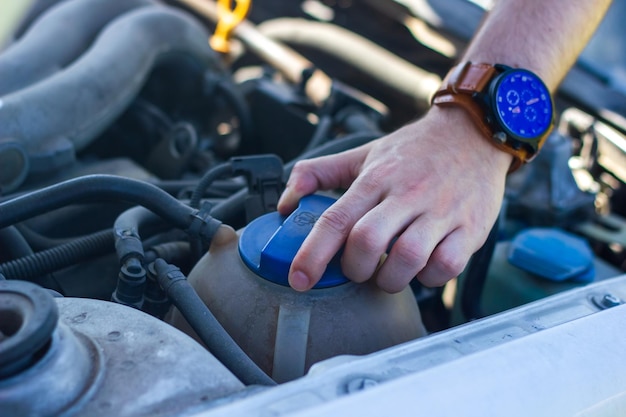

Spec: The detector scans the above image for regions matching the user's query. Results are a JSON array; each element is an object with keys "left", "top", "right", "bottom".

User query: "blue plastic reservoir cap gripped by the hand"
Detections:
[{"left": 239, "top": 195, "right": 348, "bottom": 288}]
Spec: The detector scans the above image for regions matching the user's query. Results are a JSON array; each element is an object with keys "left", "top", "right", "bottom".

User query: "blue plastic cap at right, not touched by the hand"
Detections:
[{"left": 508, "top": 228, "right": 595, "bottom": 282}]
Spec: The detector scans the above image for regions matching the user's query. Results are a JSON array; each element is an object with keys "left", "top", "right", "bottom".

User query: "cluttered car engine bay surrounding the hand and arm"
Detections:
[{"left": 0, "top": 0, "right": 626, "bottom": 417}]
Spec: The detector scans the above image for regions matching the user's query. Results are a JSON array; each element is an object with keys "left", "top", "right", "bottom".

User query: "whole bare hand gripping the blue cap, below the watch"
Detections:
[{"left": 278, "top": 107, "right": 511, "bottom": 292}]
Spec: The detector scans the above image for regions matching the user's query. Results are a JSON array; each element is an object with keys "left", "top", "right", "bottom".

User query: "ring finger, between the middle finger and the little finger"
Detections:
[{"left": 376, "top": 215, "right": 447, "bottom": 293}]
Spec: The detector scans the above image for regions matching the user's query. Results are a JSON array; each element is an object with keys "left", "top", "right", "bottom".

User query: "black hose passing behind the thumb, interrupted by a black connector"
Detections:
[{"left": 210, "top": 132, "right": 380, "bottom": 224}]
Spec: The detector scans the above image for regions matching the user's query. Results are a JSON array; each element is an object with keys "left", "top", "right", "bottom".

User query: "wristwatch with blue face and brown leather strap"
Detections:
[{"left": 432, "top": 61, "right": 554, "bottom": 172}]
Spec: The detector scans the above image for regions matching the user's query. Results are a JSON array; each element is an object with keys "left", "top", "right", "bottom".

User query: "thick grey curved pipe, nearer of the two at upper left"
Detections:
[{"left": 0, "top": 6, "right": 219, "bottom": 192}]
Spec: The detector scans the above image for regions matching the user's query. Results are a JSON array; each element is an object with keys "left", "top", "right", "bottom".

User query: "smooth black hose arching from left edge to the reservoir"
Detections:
[{"left": 0, "top": 175, "right": 209, "bottom": 244}]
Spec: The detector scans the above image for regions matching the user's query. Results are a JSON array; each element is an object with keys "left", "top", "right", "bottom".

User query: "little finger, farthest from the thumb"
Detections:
[{"left": 417, "top": 229, "right": 476, "bottom": 287}]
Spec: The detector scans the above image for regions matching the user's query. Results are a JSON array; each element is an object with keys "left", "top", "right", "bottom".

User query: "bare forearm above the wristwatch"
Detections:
[{"left": 463, "top": 0, "right": 611, "bottom": 91}]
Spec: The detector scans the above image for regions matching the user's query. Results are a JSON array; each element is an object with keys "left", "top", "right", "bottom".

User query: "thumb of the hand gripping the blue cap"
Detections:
[{"left": 278, "top": 147, "right": 364, "bottom": 214}]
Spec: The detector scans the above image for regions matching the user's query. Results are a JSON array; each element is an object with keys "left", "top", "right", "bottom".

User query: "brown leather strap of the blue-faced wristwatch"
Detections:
[{"left": 432, "top": 61, "right": 532, "bottom": 173}]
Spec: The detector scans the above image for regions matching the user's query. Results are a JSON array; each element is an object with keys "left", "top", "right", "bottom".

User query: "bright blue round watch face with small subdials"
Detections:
[{"left": 492, "top": 69, "right": 553, "bottom": 140}]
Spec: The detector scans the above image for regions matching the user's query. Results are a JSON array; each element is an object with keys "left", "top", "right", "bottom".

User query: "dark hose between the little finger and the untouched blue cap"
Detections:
[{"left": 461, "top": 219, "right": 500, "bottom": 321}]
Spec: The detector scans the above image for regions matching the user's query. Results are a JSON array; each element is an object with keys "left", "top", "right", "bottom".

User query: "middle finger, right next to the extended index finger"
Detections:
[{"left": 341, "top": 199, "right": 414, "bottom": 282}]
